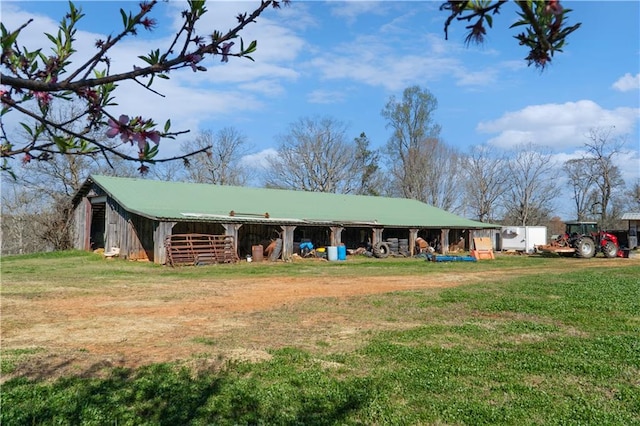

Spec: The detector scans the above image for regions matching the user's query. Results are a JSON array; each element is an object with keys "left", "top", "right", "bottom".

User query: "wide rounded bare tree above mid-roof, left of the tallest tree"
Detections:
[{"left": 265, "top": 117, "right": 362, "bottom": 194}]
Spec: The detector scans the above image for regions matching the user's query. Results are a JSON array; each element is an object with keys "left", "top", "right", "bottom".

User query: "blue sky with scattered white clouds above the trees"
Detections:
[{"left": 1, "top": 0, "right": 640, "bottom": 188}]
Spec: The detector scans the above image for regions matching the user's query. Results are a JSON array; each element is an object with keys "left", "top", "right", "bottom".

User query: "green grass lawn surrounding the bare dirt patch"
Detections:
[{"left": 0, "top": 253, "right": 640, "bottom": 425}]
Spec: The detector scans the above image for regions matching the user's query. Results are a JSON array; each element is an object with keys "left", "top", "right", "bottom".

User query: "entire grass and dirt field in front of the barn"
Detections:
[{"left": 0, "top": 252, "right": 640, "bottom": 425}]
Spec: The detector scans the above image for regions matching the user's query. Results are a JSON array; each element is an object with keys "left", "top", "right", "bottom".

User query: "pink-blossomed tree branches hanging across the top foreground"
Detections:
[{"left": 0, "top": 0, "right": 580, "bottom": 173}]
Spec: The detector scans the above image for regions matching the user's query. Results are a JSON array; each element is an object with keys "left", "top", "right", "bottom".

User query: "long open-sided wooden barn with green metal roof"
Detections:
[{"left": 73, "top": 175, "right": 500, "bottom": 264}]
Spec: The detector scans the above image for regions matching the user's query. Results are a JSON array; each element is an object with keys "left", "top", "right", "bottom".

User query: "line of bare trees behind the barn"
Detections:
[{"left": 2, "top": 86, "right": 640, "bottom": 254}]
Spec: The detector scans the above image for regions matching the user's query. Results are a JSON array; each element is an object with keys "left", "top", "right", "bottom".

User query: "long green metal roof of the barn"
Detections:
[{"left": 78, "top": 175, "right": 499, "bottom": 229}]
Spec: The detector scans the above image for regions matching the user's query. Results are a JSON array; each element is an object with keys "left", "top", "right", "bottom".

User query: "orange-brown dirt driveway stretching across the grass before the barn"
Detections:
[{"left": 2, "top": 259, "right": 629, "bottom": 379}]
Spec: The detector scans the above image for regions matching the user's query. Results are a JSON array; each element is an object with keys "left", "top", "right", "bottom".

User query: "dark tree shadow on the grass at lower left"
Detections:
[{"left": 0, "top": 364, "right": 368, "bottom": 425}]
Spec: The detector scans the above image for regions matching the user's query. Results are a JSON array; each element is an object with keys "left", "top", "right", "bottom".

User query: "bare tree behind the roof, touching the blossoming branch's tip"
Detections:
[{"left": 182, "top": 127, "right": 250, "bottom": 185}]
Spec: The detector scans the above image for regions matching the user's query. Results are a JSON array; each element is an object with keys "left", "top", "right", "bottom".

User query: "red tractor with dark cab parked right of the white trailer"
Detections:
[{"left": 538, "top": 221, "right": 623, "bottom": 259}]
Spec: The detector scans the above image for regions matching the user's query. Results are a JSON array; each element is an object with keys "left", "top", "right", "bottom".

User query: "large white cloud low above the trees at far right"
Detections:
[{"left": 476, "top": 100, "right": 640, "bottom": 150}]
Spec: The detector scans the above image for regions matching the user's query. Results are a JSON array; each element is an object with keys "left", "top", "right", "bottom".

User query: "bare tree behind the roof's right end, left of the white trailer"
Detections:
[{"left": 461, "top": 145, "right": 510, "bottom": 222}]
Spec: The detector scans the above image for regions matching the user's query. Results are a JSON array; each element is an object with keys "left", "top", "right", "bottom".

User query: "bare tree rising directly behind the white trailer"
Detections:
[{"left": 505, "top": 143, "right": 560, "bottom": 226}]
